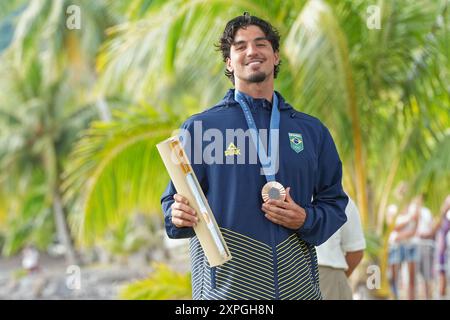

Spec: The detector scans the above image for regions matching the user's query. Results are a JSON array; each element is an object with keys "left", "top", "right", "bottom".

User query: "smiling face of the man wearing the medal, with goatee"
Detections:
[{"left": 226, "top": 25, "right": 280, "bottom": 83}]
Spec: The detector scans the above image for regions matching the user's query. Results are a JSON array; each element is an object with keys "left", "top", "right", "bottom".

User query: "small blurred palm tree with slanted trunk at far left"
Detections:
[{"left": 0, "top": 55, "right": 99, "bottom": 262}]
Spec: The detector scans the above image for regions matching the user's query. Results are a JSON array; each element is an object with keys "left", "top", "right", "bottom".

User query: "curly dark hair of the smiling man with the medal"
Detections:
[{"left": 216, "top": 12, "right": 281, "bottom": 84}]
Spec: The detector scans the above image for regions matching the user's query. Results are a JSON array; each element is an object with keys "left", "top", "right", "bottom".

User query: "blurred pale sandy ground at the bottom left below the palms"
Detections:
[{"left": 0, "top": 240, "right": 189, "bottom": 300}]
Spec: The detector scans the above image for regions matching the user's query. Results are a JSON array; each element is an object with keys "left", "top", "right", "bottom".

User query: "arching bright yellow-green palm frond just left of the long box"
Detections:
[{"left": 63, "top": 107, "right": 181, "bottom": 243}]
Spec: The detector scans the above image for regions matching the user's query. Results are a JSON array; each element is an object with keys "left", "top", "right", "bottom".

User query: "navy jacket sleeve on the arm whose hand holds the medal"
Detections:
[{"left": 298, "top": 126, "right": 348, "bottom": 246}]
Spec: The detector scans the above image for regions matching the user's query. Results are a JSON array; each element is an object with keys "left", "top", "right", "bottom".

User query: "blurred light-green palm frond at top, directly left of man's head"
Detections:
[{"left": 97, "top": 0, "right": 284, "bottom": 110}]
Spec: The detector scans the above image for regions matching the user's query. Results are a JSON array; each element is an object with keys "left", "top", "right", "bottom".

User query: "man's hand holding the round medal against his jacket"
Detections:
[{"left": 261, "top": 187, "right": 306, "bottom": 230}]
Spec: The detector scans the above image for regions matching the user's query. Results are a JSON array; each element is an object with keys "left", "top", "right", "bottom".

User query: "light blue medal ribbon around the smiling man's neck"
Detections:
[{"left": 234, "top": 90, "right": 280, "bottom": 182}]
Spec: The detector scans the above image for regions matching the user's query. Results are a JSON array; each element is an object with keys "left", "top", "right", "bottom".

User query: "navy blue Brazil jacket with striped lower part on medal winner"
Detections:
[{"left": 161, "top": 90, "right": 348, "bottom": 299}]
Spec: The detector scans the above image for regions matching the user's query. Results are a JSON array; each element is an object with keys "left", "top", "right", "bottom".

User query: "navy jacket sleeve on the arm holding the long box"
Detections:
[{"left": 161, "top": 120, "right": 207, "bottom": 239}]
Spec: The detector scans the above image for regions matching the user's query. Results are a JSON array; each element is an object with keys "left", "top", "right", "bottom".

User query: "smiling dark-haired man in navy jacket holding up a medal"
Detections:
[{"left": 161, "top": 14, "right": 348, "bottom": 299}]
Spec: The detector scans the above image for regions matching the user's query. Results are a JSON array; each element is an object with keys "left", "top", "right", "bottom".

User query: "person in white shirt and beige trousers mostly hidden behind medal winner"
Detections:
[{"left": 316, "top": 199, "right": 366, "bottom": 300}]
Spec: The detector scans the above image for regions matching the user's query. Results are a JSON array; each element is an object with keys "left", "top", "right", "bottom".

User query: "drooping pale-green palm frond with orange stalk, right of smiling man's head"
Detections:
[{"left": 284, "top": 1, "right": 368, "bottom": 223}]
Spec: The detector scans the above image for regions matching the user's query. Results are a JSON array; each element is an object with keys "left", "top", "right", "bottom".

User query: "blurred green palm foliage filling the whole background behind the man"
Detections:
[{"left": 0, "top": 0, "right": 450, "bottom": 268}]
